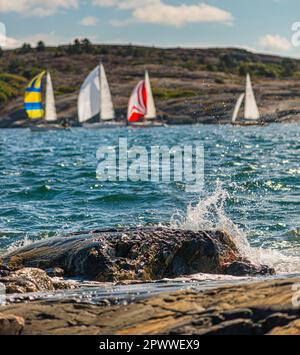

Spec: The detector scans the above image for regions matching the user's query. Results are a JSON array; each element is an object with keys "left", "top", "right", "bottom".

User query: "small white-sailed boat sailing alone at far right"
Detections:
[{"left": 231, "top": 74, "right": 261, "bottom": 126}]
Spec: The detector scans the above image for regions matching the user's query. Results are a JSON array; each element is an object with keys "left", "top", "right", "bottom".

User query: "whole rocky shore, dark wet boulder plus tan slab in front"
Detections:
[{"left": 0, "top": 228, "right": 300, "bottom": 335}]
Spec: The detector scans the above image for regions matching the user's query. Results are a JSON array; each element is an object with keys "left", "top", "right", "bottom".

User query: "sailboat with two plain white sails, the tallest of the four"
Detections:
[{"left": 78, "top": 63, "right": 120, "bottom": 128}]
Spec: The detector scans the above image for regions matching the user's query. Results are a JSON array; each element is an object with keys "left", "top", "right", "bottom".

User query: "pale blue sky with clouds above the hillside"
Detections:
[{"left": 0, "top": 0, "right": 300, "bottom": 58}]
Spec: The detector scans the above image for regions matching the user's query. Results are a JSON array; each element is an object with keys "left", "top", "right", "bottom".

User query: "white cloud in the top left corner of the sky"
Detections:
[{"left": 0, "top": 0, "right": 79, "bottom": 17}]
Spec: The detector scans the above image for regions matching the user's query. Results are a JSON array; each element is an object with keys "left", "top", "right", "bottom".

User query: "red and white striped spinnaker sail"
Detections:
[{"left": 128, "top": 80, "right": 147, "bottom": 122}]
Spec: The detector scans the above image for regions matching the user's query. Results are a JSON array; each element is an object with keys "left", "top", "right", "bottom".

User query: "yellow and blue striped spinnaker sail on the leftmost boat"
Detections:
[{"left": 24, "top": 71, "right": 46, "bottom": 119}]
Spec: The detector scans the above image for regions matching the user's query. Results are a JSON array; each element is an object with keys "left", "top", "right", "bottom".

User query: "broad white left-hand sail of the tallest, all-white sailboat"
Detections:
[{"left": 78, "top": 65, "right": 100, "bottom": 122}]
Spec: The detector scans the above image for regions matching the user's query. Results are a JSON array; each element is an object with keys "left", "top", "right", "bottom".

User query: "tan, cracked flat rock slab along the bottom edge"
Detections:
[{"left": 0, "top": 278, "right": 300, "bottom": 335}]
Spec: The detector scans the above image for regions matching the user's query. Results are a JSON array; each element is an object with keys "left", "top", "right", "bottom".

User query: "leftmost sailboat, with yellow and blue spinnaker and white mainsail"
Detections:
[{"left": 24, "top": 71, "right": 62, "bottom": 130}]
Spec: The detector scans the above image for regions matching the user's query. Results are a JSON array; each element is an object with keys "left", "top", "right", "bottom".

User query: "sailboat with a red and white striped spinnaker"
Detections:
[{"left": 127, "top": 71, "right": 162, "bottom": 127}]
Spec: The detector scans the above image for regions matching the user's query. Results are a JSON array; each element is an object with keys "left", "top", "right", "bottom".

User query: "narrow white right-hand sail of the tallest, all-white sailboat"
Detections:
[{"left": 100, "top": 63, "right": 115, "bottom": 120}]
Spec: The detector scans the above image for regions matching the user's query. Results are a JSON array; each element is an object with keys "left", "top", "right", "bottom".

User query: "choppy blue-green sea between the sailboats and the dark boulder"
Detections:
[{"left": 0, "top": 124, "right": 300, "bottom": 272}]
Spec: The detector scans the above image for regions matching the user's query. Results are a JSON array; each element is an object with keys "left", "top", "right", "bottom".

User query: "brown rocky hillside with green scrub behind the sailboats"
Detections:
[{"left": 0, "top": 40, "right": 300, "bottom": 127}]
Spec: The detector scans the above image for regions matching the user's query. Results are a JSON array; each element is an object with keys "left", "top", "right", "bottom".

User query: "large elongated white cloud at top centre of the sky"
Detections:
[{"left": 93, "top": 0, "right": 233, "bottom": 27}]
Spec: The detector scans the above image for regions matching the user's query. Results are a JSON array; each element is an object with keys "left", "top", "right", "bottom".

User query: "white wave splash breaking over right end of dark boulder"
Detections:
[{"left": 171, "top": 181, "right": 300, "bottom": 274}]
